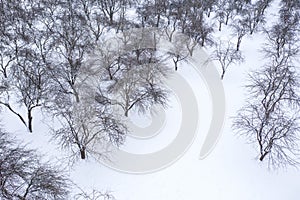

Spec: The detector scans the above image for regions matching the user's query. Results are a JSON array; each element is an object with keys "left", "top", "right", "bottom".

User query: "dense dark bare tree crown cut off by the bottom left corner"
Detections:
[{"left": 0, "top": 130, "right": 70, "bottom": 200}]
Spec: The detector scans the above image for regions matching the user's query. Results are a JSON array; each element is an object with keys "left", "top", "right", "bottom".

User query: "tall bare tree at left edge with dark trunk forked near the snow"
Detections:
[{"left": 0, "top": 2, "right": 50, "bottom": 132}]
